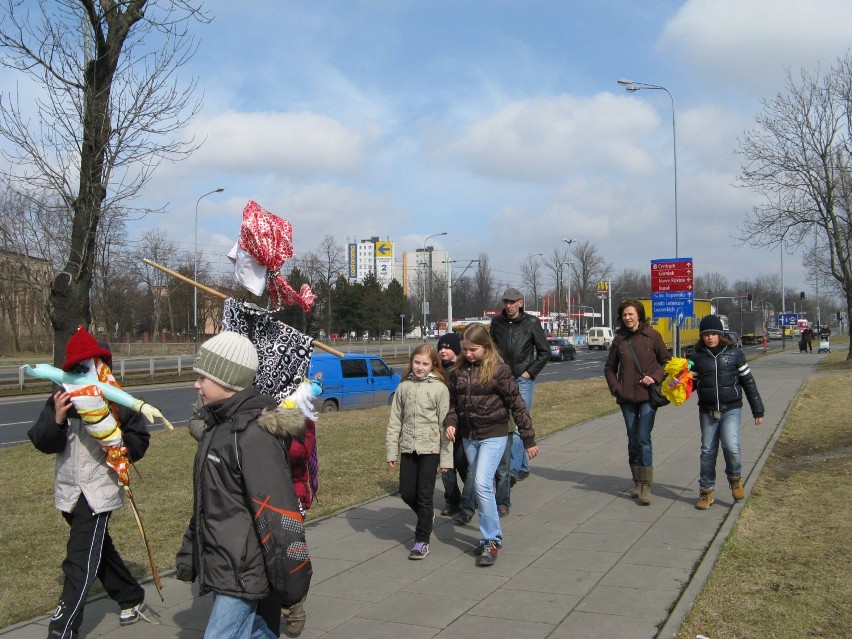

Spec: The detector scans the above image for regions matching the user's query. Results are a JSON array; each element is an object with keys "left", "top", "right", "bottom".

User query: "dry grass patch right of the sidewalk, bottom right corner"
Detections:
[{"left": 677, "top": 352, "right": 852, "bottom": 639}]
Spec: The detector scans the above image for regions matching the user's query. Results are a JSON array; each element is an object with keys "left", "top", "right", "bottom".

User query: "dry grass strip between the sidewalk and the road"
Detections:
[{"left": 0, "top": 379, "right": 615, "bottom": 628}]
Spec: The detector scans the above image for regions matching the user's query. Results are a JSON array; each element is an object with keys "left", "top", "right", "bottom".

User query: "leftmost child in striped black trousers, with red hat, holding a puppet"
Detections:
[{"left": 27, "top": 327, "right": 150, "bottom": 639}]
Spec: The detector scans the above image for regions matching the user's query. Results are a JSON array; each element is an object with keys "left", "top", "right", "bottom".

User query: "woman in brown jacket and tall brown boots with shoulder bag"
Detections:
[{"left": 604, "top": 300, "right": 671, "bottom": 506}]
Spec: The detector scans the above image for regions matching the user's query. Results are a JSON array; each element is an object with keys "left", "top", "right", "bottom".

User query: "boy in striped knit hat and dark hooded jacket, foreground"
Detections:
[{"left": 176, "top": 331, "right": 312, "bottom": 637}]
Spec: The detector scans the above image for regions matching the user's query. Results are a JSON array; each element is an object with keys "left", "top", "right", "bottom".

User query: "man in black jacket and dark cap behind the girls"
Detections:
[{"left": 490, "top": 288, "right": 550, "bottom": 516}]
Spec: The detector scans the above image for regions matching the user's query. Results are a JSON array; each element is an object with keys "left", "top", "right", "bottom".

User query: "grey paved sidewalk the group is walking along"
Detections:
[{"left": 0, "top": 351, "right": 821, "bottom": 639}]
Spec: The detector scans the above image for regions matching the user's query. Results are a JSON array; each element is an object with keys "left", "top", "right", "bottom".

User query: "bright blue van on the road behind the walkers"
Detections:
[{"left": 308, "top": 353, "right": 401, "bottom": 413}]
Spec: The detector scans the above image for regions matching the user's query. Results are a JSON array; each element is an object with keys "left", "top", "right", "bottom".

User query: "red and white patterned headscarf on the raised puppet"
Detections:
[{"left": 239, "top": 200, "right": 314, "bottom": 312}]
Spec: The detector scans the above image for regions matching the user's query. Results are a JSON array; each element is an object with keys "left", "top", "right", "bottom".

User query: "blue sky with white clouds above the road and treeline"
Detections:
[{"left": 123, "top": 0, "right": 852, "bottom": 296}]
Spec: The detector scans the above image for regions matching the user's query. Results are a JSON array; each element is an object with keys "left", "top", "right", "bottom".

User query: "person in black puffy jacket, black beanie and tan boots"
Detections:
[{"left": 692, "top": 315, "right": 764, "bottom": 510}]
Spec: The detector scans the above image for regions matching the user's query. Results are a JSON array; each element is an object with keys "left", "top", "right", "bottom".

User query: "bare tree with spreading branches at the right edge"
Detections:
[{"left": 739, "top": 53, "right": 852, "bottom": 360}]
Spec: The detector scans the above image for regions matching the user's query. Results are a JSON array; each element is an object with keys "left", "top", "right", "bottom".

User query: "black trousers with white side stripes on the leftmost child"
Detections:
[{"left": 47, "top": 495, "right": 145, "bottom": 639}]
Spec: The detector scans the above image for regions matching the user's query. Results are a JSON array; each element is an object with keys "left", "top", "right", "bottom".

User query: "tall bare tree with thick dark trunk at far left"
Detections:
[{"left": 0, "top": 0, "right": 207, "bottom": 363}]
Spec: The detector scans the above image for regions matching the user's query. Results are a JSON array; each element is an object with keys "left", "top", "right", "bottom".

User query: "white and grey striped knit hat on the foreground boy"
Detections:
[{"left": 192, "top": 331, "right": 258, "bottom": 391}]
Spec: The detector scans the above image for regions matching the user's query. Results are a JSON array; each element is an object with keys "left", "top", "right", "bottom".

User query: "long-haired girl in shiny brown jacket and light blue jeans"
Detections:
[{"left": 444, "top": 324, "right": 538, "bottom": 566}]
